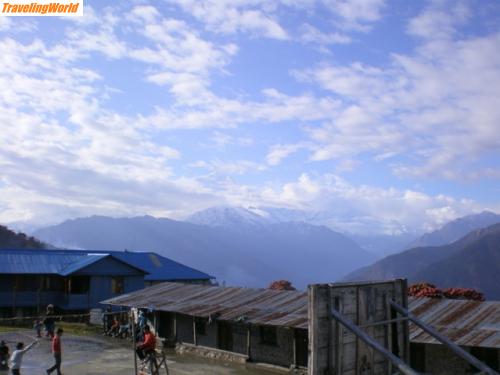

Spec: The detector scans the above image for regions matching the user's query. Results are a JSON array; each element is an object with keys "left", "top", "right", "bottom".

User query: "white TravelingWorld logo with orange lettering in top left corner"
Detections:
[{"left": 0, "top": 0, "right": 83, "bottom": 17}]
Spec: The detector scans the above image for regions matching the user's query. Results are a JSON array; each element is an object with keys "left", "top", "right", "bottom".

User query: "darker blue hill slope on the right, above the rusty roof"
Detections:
[{"left": 345, "top": 224, "right": 500, "bottom": 299}]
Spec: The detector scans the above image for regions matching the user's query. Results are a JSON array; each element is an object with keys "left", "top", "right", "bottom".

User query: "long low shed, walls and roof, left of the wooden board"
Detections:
[{"left": 103, "top": 282, "right": 308, "bottom": 367}]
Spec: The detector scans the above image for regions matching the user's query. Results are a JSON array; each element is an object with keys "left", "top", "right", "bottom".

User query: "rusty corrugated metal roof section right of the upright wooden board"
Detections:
[{"left": 408, "top": 298, "right": 500, "bottom": 348}]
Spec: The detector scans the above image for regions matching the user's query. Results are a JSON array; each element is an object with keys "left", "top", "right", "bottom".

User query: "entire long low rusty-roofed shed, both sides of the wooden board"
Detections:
[{"left": 103, "top": 282, "right": 500, "bottom": 375}]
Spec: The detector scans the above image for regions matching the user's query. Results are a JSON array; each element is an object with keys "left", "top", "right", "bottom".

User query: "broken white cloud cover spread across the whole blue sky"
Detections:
[{"left": 0, "top": 0, "right": 500, "bottom": 232}]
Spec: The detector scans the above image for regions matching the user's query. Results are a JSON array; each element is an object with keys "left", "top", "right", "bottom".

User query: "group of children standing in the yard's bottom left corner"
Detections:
[{"left": 0, "top": 305, "right": 63, "bottom": 375}]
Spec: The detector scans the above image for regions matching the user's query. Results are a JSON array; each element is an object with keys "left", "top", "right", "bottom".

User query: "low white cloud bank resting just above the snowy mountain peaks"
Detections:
[{"left": 244, "top": 174, "right": 480, "bottom": 234}]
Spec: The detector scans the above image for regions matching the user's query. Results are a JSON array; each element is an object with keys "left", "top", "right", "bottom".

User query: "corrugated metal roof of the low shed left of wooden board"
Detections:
[{"left": 102, "top": 282, "right": 308, "bottom": 329}]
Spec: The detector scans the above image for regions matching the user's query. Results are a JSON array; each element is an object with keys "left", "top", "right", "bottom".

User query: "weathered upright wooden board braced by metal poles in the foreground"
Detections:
[{"left": 309, "top": 279, "right": 409, "bottom": 375}]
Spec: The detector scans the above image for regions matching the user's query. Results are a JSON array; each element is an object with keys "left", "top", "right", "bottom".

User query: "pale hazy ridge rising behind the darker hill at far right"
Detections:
[{"left": 406, "top": 211, "right": 500, "bottom": 248}]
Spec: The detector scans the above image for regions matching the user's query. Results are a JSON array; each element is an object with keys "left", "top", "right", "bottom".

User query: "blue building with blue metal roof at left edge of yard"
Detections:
[{"left": 0, "top": 249, "right": 213, "bottom": 316}]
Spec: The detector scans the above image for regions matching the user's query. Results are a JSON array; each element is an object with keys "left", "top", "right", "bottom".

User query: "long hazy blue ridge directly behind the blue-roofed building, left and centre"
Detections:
[{"left": 35, "top": 212, "right": 375, "bottom": 288}]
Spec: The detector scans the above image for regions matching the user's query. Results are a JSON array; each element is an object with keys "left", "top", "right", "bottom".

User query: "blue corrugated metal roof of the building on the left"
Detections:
[{"left": 0, "top": 249, "right": 214, "bottom": 281}]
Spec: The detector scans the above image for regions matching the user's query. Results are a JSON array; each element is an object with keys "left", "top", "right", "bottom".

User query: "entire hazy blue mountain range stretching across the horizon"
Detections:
[{"left": 4, "top": 206, "right": 500, "bottom": 298}]
